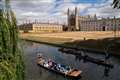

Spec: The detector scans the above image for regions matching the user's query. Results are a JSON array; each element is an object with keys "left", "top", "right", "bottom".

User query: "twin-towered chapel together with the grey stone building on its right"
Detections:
[{"left": 67, "top": 7, "right": 120, "bottom": 31}]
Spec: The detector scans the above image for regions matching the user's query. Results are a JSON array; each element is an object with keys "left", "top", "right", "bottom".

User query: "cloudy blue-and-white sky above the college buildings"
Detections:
[{"left": 0, "top": 0, "right": 120, "bottom": 24}]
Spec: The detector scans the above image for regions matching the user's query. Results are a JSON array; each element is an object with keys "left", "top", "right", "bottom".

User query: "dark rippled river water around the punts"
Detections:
[{"left": 22, "top": 41, "right": 120, "bottom": 80}]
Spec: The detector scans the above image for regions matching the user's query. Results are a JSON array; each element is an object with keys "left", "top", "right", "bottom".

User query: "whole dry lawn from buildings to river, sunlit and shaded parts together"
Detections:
[{"left": 20, "top": 32, "right": 120, "bottom": 56}]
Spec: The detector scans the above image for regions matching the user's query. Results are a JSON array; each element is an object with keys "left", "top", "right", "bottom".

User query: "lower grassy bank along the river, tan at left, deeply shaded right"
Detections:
[{"left": 21, "top": 36, "right": 120, "bottom": 56}]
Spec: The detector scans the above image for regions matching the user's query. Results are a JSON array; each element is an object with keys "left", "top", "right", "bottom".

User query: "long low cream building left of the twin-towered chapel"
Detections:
[{"left": 19, "top": 23, "right": 63, "bottom": 32}]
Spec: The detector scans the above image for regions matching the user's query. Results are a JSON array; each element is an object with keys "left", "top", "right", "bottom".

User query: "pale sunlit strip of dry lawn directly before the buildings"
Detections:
[{"left": 20, "top": 31, "right": 120, "bottom": 40}]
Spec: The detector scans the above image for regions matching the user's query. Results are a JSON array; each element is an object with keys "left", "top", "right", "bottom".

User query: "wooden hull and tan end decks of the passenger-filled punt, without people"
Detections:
[{"left": 37, "top": 57, "right": 82, "bottom": 78}]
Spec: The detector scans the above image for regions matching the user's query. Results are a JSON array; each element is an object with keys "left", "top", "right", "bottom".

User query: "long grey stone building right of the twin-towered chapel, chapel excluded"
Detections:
[{"left": 79, "top": 18, "right": 120, "bottom": 31}]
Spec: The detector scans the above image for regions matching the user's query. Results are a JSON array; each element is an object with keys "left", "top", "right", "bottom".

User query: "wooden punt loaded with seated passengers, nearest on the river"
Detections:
[{"left": 37, "top": 53, "right": 82, "bottom": 78}]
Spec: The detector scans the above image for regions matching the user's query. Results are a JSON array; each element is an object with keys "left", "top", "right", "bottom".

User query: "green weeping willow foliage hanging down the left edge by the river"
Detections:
[{"left": 0, "top": 0, "right": 24, "bottom": 80}]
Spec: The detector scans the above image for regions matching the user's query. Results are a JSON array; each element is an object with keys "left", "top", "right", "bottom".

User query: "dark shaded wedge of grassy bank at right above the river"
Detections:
[{"left": 64, "top": 38, "right": 120, "bottom": 56}]
